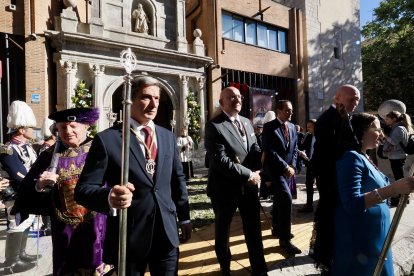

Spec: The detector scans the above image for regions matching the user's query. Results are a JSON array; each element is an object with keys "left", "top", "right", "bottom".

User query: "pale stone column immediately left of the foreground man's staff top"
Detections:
[{"left": 89, "top": 64, "right": 106, "bottom": 130}]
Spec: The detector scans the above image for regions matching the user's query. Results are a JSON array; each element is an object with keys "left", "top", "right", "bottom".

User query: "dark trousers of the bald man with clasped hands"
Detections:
[{"left": 211, "top": 190, "right": 267, "bottom": 275}]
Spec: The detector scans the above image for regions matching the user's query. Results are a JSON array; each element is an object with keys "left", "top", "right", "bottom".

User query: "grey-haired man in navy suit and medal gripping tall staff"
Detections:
[{"left": 75, "top": 77, "right": 191, "bottom": 275}]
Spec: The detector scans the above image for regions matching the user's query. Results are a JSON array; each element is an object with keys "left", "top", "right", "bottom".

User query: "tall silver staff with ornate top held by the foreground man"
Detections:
[{"left": 113, "top": 48, "right": 137, "bottom": 276}]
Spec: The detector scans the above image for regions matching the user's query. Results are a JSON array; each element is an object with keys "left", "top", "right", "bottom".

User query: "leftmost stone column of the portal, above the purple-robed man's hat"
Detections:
[{"left": 56, "top": 60, "right": 78, "bottom": 111}]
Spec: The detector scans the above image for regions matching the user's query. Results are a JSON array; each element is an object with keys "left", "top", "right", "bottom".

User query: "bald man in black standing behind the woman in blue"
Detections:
[{"left": 312, "top": 84, "right": 360, "bottom": 271}]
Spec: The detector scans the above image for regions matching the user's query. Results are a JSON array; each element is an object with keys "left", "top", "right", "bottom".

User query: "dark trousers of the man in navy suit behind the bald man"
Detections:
[{"left": 272, "top": 178, "right": 292, "bottom": 241}]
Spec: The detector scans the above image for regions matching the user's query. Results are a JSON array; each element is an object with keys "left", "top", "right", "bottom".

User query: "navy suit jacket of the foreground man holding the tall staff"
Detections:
[{"left": 75, "top": 125, "right": 190, "bottom": 264}]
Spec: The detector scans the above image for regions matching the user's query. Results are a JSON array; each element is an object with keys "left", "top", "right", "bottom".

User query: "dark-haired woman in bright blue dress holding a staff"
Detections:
[{"left": 333, "top": 113, "right": 414, "bottom": 276}]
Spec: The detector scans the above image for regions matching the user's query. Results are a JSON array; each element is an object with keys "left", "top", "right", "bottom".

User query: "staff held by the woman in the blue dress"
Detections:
[{"left": 372, "top": 194, "right": 410, "bottom": 276}]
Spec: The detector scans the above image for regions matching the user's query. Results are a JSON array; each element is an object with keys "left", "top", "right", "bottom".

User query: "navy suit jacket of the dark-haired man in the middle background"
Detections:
[{"left": 263, "top": 119, "right": 298, "bottom": 181}]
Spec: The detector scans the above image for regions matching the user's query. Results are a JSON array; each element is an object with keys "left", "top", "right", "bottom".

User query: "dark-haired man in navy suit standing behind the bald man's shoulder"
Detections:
[{"left": 263, "top": 100, "right": 302, "bottom": 255}]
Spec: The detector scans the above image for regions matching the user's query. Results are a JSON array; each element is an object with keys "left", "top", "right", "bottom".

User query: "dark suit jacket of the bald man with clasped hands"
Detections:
[{"left": 205, "top": 112, "right": 261, "bottom": 200}]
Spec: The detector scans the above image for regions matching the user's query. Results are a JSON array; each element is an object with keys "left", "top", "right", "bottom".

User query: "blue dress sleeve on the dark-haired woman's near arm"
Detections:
[{"left": 336, "top": 151, "right": 365, "bottom": 214}]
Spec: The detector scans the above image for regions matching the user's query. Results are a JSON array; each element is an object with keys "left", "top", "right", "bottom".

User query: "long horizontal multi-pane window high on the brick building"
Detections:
[{"left": 222, "top": 11, "right": 287, "bottom": 53}]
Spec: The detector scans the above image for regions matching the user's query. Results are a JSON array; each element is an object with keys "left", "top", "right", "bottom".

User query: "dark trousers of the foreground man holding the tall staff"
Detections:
[{"left": 126, "top": 209, "right": 179, "bottom": 276}]
